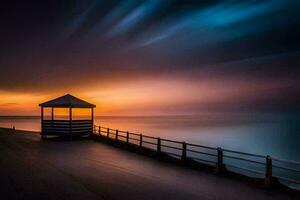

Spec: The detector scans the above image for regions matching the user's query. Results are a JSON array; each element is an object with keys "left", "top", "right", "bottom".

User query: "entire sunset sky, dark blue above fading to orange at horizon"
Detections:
[{"left": 0, "top": 0, "right": 300, "bottom": 115}]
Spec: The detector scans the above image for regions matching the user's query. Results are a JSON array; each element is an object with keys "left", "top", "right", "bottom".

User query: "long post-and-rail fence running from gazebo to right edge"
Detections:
[{"left": 93, "top": 126, "right": 300, "bottom": 188}]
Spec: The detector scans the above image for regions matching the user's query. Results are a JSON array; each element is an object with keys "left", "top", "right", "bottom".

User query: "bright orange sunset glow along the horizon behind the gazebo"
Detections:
[{"left": 0, "top": 78, "right": 290, "bottom": 116}]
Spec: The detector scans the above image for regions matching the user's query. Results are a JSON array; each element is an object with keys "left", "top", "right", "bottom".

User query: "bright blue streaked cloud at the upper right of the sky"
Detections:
[{"left": 135, "top": 0, "right": 295, "bottom": 47}]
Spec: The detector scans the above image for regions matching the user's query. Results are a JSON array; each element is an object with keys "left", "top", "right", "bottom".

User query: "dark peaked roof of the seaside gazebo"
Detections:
[{"left": 39, "top": 94, "right": 96, "bottom": 108}]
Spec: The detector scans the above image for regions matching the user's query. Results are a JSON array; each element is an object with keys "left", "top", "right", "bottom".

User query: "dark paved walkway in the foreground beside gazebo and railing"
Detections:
[{"left": 0, "top": 129, "right": 299, "bottom": 200}]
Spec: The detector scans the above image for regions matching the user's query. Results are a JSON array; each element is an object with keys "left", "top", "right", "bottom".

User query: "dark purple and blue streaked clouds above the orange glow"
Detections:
[{"left": 0, "top": 0, "right": 300, "bottom": 111}]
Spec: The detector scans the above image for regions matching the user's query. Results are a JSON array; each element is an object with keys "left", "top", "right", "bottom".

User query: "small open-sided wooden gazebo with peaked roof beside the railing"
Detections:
[{"left": 39, "top": 94, "right": 96, "bottom": 139}]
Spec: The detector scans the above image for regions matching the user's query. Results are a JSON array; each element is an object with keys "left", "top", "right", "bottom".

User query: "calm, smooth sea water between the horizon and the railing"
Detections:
[{"left": 0, "top": 113, "right": 300, "bottom": 161}]
